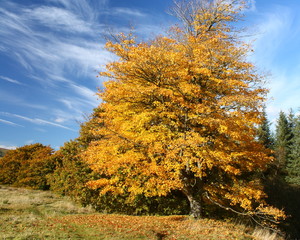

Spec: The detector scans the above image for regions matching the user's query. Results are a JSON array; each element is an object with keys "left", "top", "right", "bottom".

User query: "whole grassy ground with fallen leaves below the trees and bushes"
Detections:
[{"left": 0, "top": 186, "right": 278, "bottom": 240}]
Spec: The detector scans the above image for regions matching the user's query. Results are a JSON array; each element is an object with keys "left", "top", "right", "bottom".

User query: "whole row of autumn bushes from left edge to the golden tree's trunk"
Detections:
[{"left": 0, "top": 120, "right": 188, "bottom": 215}]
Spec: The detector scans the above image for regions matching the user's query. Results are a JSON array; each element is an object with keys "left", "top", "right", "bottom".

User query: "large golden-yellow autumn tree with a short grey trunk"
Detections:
[{"left": 83, "top": 0, "right": 283, "bottom": 221}]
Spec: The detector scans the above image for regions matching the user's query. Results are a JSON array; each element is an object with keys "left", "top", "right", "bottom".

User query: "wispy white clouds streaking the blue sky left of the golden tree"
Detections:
[{"left": 0, "top": 0, "right": 169, "bottom": 146}]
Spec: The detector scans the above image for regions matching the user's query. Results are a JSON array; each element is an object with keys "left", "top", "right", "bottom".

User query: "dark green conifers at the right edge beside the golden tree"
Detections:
[{"left": 264, "top": 110, "right": 300, "bottom": 239}]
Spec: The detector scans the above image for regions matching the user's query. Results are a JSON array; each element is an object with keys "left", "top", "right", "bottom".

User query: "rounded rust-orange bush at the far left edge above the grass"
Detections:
[{"left": 0, "top": 143, "right": 54, "bottom": 190}]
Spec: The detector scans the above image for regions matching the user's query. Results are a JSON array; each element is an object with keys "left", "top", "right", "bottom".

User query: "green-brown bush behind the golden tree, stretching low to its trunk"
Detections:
[{"left": 47, "top": 112, "right": 188, "bottom": 215}]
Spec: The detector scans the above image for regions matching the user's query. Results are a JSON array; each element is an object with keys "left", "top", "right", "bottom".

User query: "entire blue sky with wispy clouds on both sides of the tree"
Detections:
[{"left": 0, "top": 0, "right": 300, "bottom": 149}]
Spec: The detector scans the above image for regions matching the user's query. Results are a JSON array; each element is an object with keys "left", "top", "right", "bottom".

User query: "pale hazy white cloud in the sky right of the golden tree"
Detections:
[{"left": 253, "top": 4, "right": 300, "bottom": 122}]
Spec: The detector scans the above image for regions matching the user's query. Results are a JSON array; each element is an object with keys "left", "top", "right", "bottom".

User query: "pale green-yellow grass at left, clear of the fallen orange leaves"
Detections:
[{"left": 0, "top": 186, "right": 94, "bottom": 240}]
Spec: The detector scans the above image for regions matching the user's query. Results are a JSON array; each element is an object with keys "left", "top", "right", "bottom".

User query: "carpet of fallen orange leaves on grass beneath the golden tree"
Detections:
[{"left": 48, "top": 214, "right": 253, "bottom": 240}]
